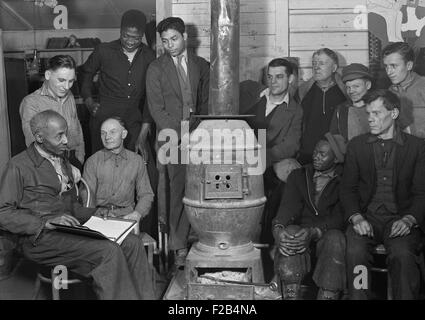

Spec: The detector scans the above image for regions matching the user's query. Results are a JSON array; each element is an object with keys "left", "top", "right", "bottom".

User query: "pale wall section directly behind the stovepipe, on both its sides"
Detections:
[{"left": 163, "top": 0, "right": 289, "bottom": 81}]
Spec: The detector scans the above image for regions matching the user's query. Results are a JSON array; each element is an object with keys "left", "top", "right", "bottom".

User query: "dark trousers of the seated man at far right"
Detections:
[{"left": 346, "top": 210, "right": 422, "bottom": 300}]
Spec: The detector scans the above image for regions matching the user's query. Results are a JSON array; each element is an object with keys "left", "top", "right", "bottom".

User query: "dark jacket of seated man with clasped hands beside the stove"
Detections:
[{"left": 273, "top": 165, "right": 344, "bottom": 232}]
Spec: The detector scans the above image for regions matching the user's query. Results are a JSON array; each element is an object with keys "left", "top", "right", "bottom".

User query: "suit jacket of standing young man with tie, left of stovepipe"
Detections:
[{"left": 146, "top": 50, "right": 209, "bottom": 137}]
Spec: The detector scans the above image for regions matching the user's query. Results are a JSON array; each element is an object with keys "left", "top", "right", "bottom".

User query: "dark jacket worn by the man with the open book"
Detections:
[{"left": 0, "top": 143, "right": 96, "bottom": 236}]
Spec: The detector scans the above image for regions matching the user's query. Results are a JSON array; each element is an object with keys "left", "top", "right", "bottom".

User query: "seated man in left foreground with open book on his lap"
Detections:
[{"left": 0, "top": 110, "right": 154, "bottom": 299}]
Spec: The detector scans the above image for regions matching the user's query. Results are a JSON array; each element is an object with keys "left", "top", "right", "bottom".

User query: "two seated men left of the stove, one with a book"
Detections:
[{"left": 0, "top": 110, "right": 155, "bottom": 299}]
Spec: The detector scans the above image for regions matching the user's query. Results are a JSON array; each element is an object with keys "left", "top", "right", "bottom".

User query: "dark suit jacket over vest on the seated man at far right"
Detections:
[{"left": 341, "top": 130, "right": 425, "bottom": 230}]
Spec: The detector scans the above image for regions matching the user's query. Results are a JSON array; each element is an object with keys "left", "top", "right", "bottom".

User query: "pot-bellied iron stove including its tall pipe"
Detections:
[{"left": 178, "top": 0, "right": 266, "bottom": 299}]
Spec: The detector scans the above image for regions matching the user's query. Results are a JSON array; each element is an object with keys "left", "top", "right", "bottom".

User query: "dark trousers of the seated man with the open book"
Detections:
[{"left": 21, "top": 230, "right": 155, "bottom": 300}]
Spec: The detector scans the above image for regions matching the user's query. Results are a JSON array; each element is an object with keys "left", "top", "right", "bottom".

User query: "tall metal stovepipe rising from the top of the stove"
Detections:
[{"left": 208, "top": 0, "right": 239, "bottom": 116}]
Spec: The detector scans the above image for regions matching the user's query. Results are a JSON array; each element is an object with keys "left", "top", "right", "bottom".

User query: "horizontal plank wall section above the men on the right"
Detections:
[{"left": 288, "top": 0, "right": 369, "bottom": 80}]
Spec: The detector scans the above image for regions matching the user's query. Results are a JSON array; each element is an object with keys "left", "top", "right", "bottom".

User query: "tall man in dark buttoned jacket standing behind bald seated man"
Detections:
[{"left": 81, "top": 10, "right": 155, "bottom": 156}]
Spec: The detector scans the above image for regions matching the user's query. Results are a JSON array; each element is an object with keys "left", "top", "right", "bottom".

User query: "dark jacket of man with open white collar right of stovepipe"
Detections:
[{"left": 246, "top": 96, "right": 303, "bottom": 167}]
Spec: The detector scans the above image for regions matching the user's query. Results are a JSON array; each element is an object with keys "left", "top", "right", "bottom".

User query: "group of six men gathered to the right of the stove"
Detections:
[{"left": 252, "top": 43, "right": 425, "bottom": 299}]
